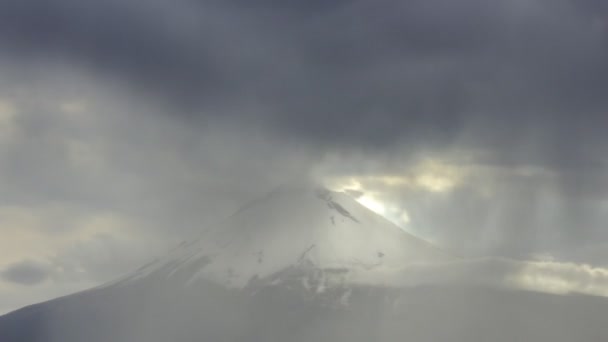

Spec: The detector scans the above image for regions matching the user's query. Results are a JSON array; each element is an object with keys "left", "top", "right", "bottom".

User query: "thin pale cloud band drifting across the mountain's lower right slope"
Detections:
[{"left": 350, "top": 258, "right": 608, "bottom": 297}]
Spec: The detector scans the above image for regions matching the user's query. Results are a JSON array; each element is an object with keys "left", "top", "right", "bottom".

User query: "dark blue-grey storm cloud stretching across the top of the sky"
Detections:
[{"left": 0, "top": 0, "right": 608, "bottom": 152}]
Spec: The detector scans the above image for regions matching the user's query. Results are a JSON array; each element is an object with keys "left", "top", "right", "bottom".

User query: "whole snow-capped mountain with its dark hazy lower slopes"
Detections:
[{"left": 0, "top": 184, "right": 608, "bottom": 342}]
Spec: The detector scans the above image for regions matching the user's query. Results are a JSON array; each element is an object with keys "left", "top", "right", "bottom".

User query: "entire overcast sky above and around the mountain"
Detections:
[{"left": 0, "top": 0, "right": 608, "bottom": 312}]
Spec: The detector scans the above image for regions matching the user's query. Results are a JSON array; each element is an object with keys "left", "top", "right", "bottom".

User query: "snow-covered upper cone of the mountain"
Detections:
[{"left": 119, "top": 182, "right": 449, "bottom": 287}]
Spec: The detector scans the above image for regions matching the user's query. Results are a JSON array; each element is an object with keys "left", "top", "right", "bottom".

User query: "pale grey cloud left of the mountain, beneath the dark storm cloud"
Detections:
[{"left": 0, "top": 80, "right": 310, "bottom": 305}]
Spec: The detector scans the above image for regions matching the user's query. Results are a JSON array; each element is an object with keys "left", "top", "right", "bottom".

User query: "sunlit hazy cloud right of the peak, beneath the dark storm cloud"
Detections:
[{"left": 326, "top": 154, "right": 608, "bottom": 265}]
